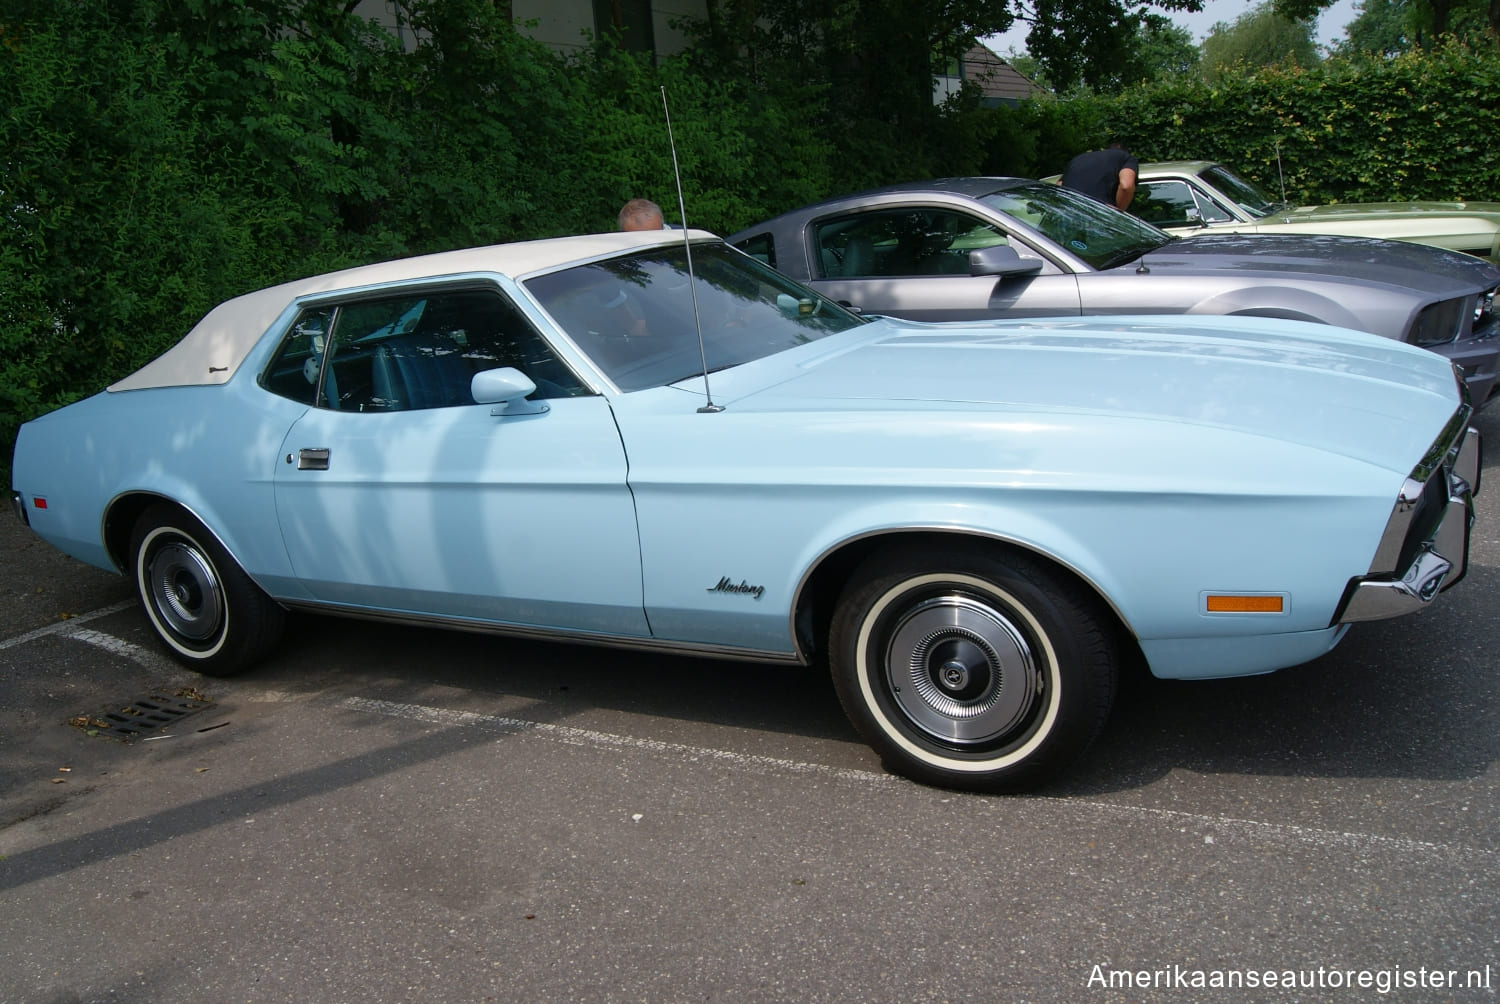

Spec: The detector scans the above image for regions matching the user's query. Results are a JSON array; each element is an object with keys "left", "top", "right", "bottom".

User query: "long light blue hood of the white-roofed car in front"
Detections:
[{"left": 683, "top": 317, "right": 1458, "bottom": 476}]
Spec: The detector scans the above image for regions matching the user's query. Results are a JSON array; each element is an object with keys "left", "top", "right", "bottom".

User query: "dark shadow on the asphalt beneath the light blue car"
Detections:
[{"left": 237, "top": 549, "right": 1500, "bottom": 794}]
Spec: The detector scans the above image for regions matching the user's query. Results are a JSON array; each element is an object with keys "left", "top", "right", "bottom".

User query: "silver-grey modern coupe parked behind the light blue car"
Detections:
[{"left": 729, "top": 177, "right": 1500, "bottom": 404}]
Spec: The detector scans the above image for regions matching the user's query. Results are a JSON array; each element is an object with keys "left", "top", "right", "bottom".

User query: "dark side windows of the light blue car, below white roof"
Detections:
[{"left": 263, "top": 288, "right": 588, "bottom": 411}]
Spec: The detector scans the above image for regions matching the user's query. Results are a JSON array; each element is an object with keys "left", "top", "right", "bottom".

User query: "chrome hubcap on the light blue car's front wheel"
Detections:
[{"left": 885, "top": 593, "right": 1041, "bottom": 746}]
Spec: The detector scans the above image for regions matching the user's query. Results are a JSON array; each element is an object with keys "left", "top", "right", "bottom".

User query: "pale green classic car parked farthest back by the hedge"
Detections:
[{"left": 1130, "top": 161, "right": 1500, "bottom": 261}]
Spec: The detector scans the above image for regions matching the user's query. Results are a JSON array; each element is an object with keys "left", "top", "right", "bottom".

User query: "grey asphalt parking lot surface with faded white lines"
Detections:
[{"left": 0, "top": 410, "right": 1500, "bottom": 1002}]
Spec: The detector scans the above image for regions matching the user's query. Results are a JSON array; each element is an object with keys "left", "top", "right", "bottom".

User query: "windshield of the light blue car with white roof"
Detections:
[{"left": 525, "top": 243, "right": 866, "bottom": 390}]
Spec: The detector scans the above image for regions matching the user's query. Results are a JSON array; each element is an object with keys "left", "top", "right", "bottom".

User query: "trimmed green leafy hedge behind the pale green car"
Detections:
[{"left": 987, "top": 44, "right": 1500, "bottom": 204}]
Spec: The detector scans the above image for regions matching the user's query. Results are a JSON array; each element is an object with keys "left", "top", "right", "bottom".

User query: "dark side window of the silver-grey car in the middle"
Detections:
[{"left": 813, "top": 207, "right": 1010, "bottom": 279}]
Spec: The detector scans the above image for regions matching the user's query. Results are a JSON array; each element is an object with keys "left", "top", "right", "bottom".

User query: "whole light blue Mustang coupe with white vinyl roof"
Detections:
[{"left": 14, "top": 231, "right": 1479, "bottom": 791}]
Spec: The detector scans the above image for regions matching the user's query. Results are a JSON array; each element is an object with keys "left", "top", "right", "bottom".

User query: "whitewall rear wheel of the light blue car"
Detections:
[{"left": 131, "top": 503, "right": 285, "bottom": 677}]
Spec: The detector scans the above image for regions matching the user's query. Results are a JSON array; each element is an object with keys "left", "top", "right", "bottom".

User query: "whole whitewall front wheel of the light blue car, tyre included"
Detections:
[{"left": 830, "top": 546, "right": 1119, "bottom": 791}]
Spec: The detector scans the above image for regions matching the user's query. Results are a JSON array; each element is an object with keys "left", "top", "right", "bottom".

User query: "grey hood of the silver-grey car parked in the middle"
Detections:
[{"left": 1122, "top": 226, "right": 1500, "bottom": 289}]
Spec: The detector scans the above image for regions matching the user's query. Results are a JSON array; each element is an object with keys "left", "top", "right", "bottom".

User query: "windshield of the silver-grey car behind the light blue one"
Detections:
[{"left": 980, "top": 182, "right": 1172, "bottom": 269}]
